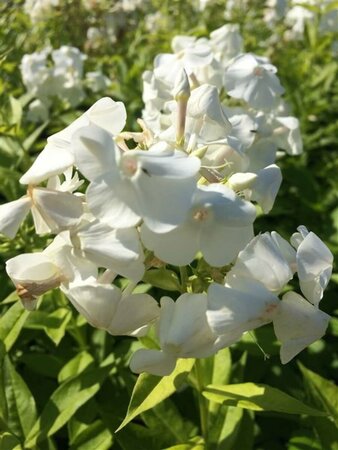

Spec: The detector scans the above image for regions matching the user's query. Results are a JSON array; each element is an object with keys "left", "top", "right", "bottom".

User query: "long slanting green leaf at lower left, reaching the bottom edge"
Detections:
[{"left": 25, "top": 365, "right": 112, "bottom": 448}]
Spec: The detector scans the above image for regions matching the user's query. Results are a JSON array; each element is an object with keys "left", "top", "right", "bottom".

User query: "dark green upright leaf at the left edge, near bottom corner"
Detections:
[{"left": 0, "top": 355, "right": 37, "bottom": 438}]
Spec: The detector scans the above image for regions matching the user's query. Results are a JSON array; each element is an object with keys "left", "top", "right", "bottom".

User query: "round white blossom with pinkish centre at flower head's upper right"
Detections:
[{"left": 224, "top": 53, "right": 284, "bottom": 110}]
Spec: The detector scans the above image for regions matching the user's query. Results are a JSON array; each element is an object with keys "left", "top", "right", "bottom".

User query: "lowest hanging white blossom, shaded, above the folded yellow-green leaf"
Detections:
[{"left": 130, "top": 294, "right": 226, "bottom": 376}]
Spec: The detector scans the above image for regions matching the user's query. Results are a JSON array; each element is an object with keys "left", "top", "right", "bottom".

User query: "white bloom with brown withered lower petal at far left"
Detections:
[{"left": 6, "top": 232, "right": 97, "bottom": 310}]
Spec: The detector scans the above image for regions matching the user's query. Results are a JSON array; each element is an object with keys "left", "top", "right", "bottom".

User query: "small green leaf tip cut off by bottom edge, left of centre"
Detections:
[{"left": 70, "top": 420, "right": 113, "bottom": 450}]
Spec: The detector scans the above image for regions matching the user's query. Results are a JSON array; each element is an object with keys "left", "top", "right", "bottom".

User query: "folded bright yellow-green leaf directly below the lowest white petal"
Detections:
[{"left": 116, "top": 359, "right": 195, "bottom": 432}]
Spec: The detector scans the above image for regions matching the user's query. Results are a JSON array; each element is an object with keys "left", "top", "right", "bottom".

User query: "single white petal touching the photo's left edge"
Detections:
[{"left": 0, "top": 195, "right": 32, "bottom": 239}]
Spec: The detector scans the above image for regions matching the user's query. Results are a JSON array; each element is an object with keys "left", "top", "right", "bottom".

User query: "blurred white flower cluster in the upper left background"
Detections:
[{"left": 20, "top": 45, "right": 110, "bottom": 121}]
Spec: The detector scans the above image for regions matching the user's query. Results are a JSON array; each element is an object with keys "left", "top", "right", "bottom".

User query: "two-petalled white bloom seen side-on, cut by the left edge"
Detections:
[{"left": 0, "top": 186, "right": 83, "bottom": 238}]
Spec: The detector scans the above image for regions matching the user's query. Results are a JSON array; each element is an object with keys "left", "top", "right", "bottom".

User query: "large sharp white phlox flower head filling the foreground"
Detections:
[{"left": 0, "top": 25, "right": 332, "bottom": 376}]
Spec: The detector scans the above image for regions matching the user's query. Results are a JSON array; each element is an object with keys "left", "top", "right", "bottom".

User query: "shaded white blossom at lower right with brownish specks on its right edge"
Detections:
[{"left": 207, "top": 278, "right": 280, "bottom": 342}]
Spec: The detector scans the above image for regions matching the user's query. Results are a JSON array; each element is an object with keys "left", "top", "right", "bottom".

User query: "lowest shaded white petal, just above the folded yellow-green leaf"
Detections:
[{"left": 130, "top": 349, "right": 176, "bottom": 377}]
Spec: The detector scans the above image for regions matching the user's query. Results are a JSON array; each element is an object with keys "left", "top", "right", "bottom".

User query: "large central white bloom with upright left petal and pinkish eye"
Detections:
[{"left": 74, "top": 125, "right": 200, "bottom": 232}]
